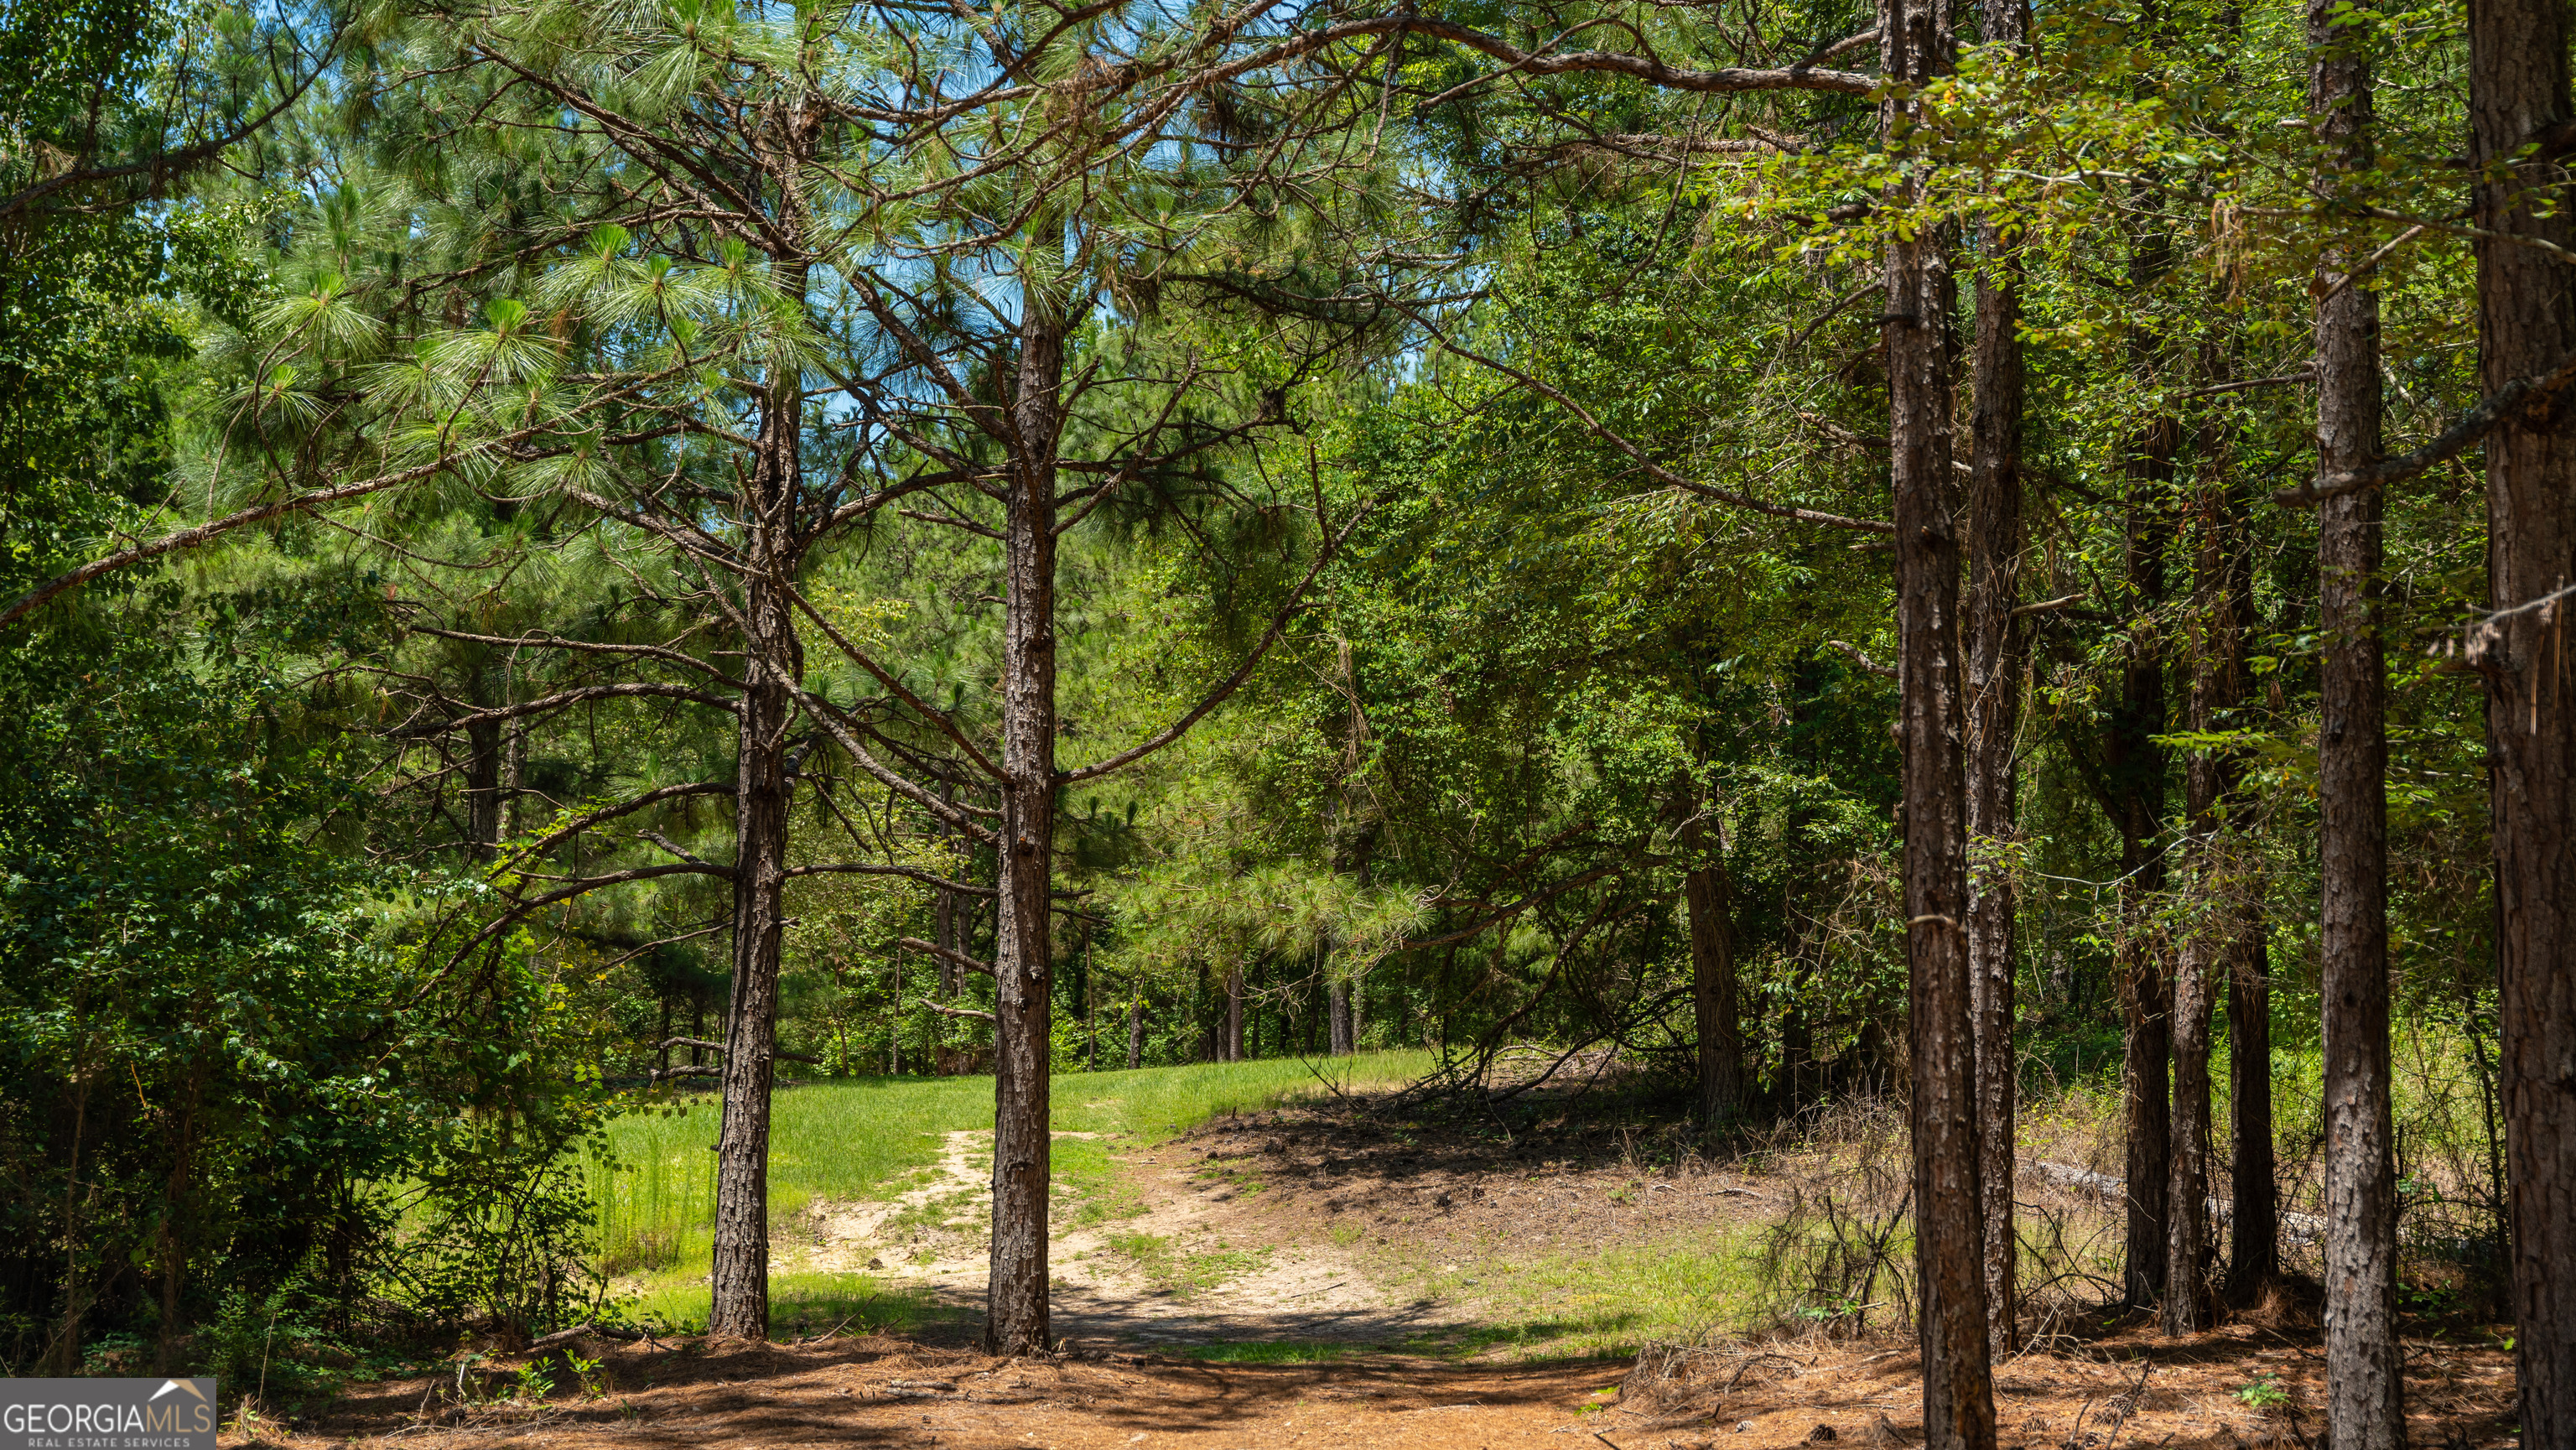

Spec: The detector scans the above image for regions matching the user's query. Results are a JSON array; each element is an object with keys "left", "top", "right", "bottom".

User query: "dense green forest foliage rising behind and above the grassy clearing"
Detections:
[{"left": 0, "top": 0, "right": 2566, "bottom": 1442}]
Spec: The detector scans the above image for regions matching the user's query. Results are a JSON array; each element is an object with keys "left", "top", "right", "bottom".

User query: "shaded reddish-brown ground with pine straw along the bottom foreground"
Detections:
[{"left": 256, "top": 1324, "right": 2514, "bottom": 1450}]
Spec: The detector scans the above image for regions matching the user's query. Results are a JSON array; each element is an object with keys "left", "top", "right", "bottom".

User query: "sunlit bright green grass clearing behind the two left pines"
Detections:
[{"left": 593, "top": 1053, "right": 1430, "bottom": 1334}]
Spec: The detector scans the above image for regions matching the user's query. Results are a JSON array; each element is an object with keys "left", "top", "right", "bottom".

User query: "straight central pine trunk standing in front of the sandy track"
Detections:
[{"left": 984, "top": 289, "right": 1067, "bottom": 1354}]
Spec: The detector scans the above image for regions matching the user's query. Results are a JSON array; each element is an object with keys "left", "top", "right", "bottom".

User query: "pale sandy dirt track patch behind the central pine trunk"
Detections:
[{"left": 776, "top": 1130, "right": 1453, "bottom": 1347}]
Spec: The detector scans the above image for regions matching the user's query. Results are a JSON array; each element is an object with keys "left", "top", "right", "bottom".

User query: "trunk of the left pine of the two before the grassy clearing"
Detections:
[{"left": 706, "top": 268, "right": 803, "bottom": 1339}]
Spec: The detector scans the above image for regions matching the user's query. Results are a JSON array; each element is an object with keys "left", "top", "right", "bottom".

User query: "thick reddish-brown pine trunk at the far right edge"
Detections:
[{"left": 2468, "top": 0, "right": 2576, "bottom": 1450}]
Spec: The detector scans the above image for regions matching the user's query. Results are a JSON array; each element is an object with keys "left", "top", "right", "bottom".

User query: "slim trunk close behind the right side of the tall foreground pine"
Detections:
[{"left": 1966, "top": 0, "right": 2030, "bottom": 1354}]
